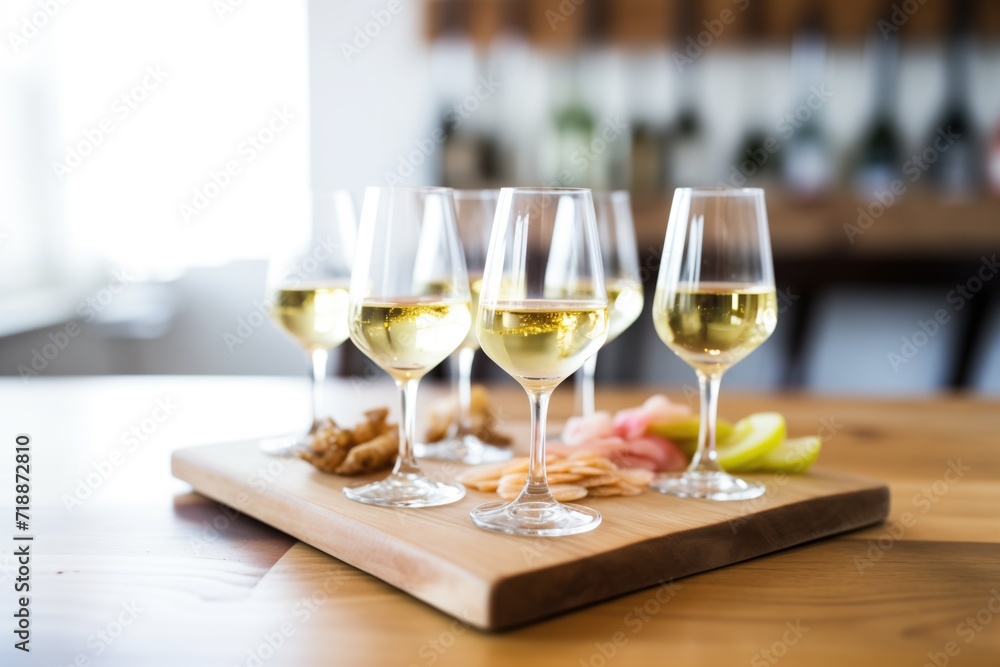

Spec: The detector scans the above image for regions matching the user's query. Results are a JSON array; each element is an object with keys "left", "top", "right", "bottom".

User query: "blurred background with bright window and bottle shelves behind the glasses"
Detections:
[{"left": 0, "top": 0, "right": 1000, "bottom": 394}]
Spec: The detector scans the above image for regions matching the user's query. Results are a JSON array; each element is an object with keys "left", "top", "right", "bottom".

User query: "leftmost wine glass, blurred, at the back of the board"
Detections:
[{"left": 260, "top": 190, "right": 357, "bottom": 456}]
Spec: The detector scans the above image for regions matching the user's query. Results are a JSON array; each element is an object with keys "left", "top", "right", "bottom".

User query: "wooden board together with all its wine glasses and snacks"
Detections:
[{"left": 173, "top": 188, "right": 888, "bottom": 628}]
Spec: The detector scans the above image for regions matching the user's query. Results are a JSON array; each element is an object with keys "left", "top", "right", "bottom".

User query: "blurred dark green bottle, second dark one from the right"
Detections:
[{"left": 854, "top": 31, "right": 902, "bottom": 199}]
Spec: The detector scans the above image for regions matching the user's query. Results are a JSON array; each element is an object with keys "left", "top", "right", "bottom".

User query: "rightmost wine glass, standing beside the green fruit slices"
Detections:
[{"left": 650, "top": 188, "right": 778, "bottom": 500}]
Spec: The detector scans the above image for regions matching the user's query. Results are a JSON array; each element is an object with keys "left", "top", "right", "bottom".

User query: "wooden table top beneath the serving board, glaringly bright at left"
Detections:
[{"left": 0, "top": 377, "right": 1000, "bottom": 667}]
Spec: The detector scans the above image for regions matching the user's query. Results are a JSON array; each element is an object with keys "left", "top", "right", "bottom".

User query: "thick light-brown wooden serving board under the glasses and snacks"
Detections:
[{"left": 172, "top": 442, "right": 889, "bottom": 630}]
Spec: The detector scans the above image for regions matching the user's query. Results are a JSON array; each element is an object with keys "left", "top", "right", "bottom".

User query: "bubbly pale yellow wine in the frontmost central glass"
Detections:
[{"left": 478, "top": 301, "right": 608, "bottom": 388}]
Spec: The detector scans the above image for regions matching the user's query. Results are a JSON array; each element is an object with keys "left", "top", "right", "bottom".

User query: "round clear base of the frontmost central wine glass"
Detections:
[{"left": 469, "top": 499, "right": 601, "bottom": 537}]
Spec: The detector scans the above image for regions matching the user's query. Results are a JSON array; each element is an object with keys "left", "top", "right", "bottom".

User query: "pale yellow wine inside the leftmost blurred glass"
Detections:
[{"left": 271, "top": 283, "right": 349, "bottom": 349}]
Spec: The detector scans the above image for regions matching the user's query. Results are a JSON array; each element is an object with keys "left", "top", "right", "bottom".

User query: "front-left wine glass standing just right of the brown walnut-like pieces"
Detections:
[{"left": 344, "top": 188, "right": 472, "bottom": 507}]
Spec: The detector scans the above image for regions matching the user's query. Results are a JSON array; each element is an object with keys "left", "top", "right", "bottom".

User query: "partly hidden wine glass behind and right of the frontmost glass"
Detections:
[{"left": 576, "top": 190, "right": 643, "bottom": 417}]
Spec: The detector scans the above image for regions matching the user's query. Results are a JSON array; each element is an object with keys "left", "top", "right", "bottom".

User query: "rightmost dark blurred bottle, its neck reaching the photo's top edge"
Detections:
[{"left": 926, "top": 0, "right": 980, "bottom": 196}]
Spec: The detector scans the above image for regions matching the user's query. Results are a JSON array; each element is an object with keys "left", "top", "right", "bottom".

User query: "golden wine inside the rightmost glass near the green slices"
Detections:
[{"left": 653, "top": 283, "right": 778, "bottom": 372}]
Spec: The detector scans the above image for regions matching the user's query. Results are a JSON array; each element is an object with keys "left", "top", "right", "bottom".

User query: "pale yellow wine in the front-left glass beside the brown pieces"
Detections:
[{"left": 351, "top": 297, "right": 472, "bottom": 380}]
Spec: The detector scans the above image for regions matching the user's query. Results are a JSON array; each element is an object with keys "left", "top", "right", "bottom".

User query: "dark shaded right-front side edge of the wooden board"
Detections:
[{"left": 480, "top": 482, "right": 890, "bottom": 631}]
